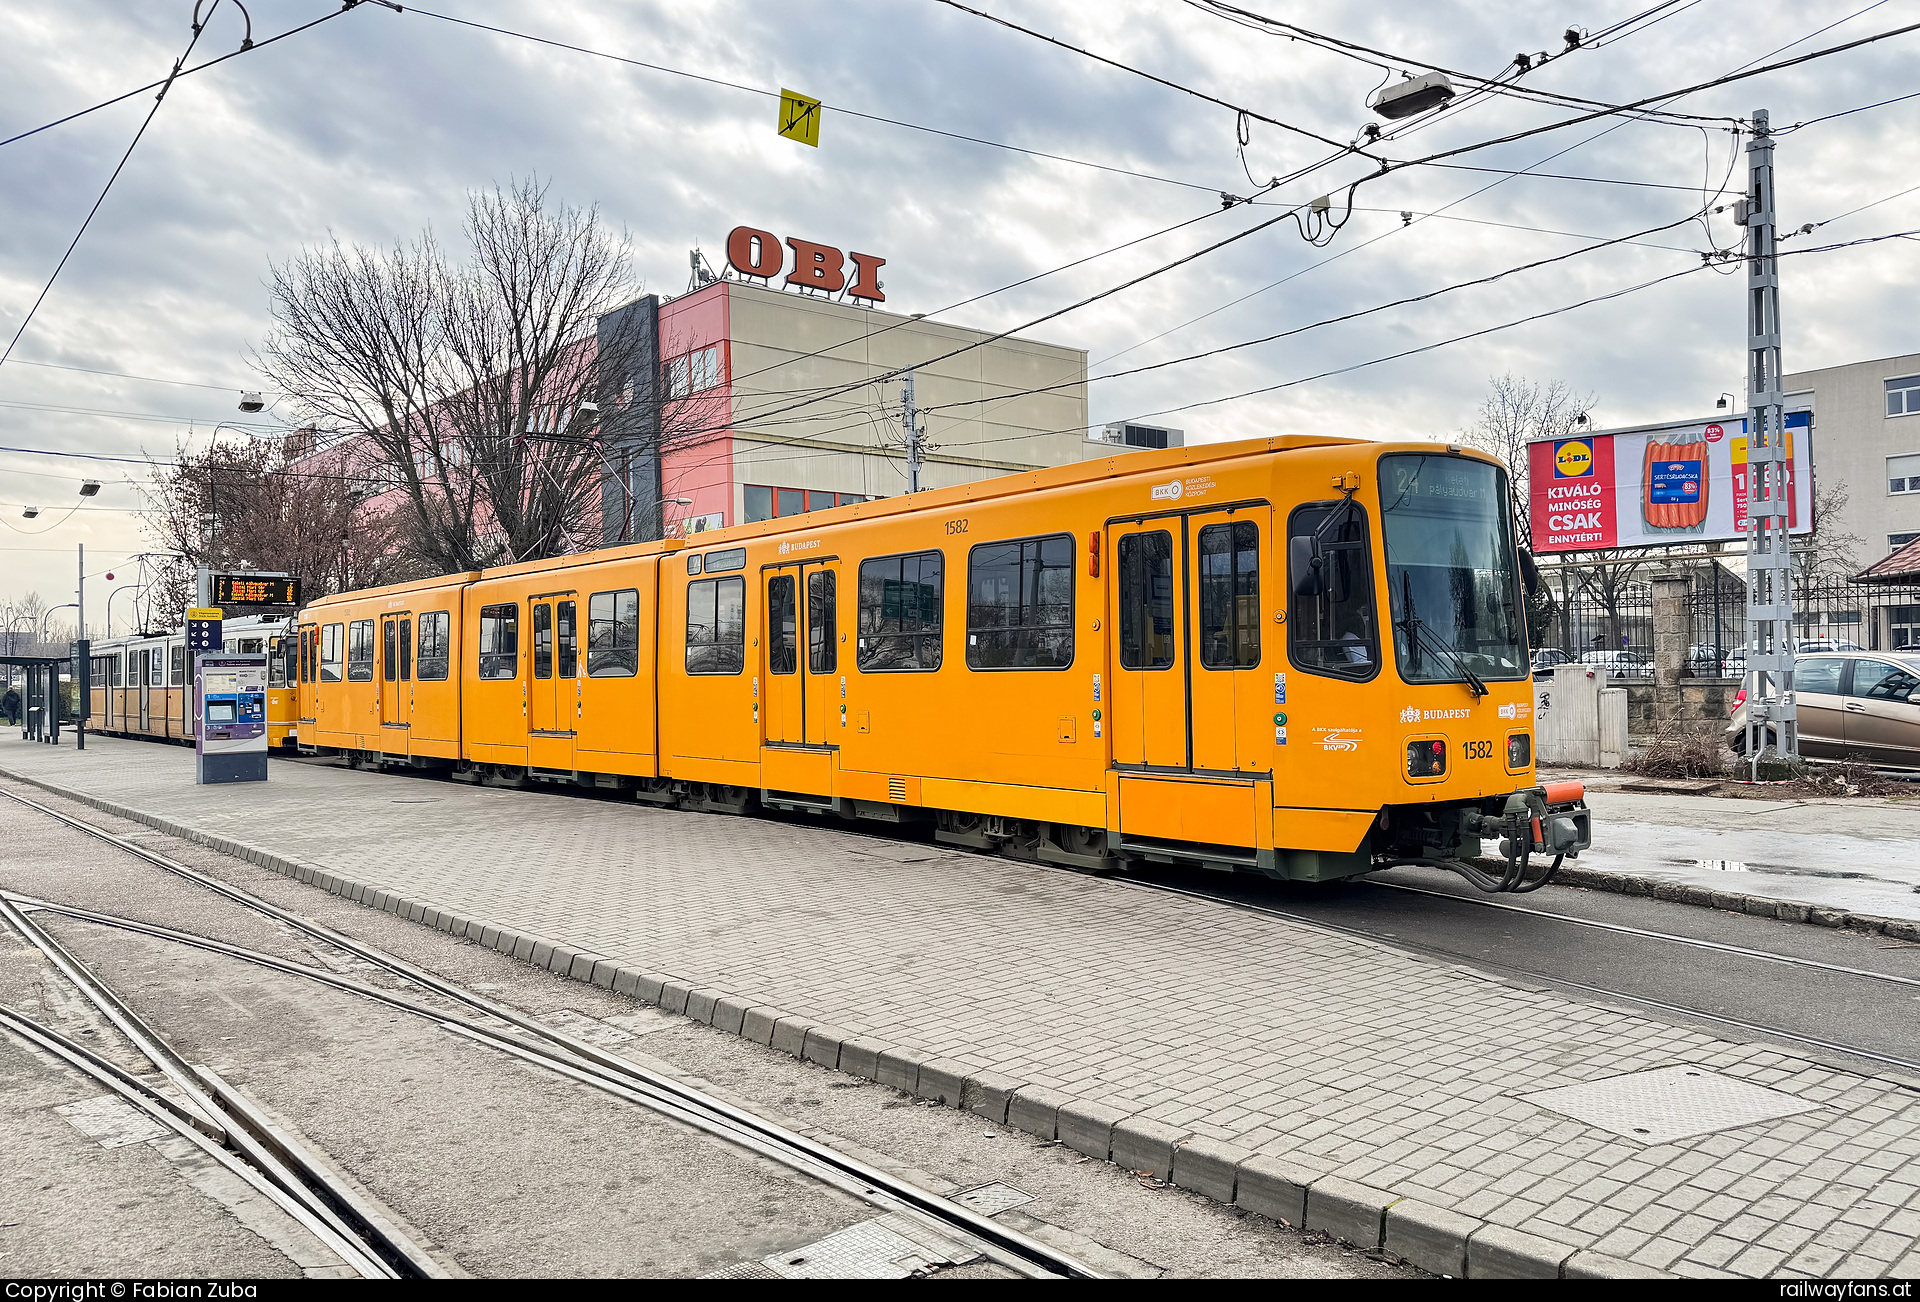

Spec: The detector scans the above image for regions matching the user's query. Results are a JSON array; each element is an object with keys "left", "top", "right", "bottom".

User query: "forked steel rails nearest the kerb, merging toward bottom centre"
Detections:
[{"left": 0, "top": 789, "right": 1100, "bottom": 1279}]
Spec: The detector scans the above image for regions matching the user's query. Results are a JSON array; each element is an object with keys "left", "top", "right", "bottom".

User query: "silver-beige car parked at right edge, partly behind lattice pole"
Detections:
[{"left": 1726, "top": 653, "right": 1920, "bottom": 770}]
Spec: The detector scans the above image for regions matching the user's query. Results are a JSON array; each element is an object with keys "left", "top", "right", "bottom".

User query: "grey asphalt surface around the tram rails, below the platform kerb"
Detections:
[{"left": 0, "top": 784, "right": 1415, "bottom": 1277}]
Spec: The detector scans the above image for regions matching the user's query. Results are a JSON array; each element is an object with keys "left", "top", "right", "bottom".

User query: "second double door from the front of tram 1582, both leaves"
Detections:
[{"left": 760, "top": 561, "right": 841, "bottom": 745}]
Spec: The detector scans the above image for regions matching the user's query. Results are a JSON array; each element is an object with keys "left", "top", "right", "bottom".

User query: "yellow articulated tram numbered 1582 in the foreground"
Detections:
[{"left": 294, "top": 436, "right": 1590, "bottom": 889}]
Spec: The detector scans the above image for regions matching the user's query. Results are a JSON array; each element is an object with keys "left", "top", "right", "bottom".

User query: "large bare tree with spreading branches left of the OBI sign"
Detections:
[{"left": 259, "top": 181, "right": 685, "bottom": 572}]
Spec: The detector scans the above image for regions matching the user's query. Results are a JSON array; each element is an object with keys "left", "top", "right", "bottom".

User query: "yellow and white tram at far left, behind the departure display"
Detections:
[{"left": 86, "top": 615, "right": 298, "bottom": 751}]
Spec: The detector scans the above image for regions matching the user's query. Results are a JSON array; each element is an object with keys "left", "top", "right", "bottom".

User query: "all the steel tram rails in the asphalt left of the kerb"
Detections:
[{"left": 0, "top": 791, "right": 1100, "bottom": 1279}]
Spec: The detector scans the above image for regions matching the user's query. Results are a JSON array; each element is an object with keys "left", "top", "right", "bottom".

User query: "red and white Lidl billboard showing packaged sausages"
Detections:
[{"left": 1526, "top": 411, "right": 1812, "bottom": 553}]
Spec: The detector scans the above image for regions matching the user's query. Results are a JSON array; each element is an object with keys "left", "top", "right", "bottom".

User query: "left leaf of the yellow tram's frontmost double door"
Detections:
[{"left": 1110, "top": 517, "right": 1190, "bottom": 768}]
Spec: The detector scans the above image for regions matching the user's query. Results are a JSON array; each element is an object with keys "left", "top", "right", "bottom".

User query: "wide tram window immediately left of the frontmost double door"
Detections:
[{"left": 966, "top": 534, "right": 1073, "bottom": 668}]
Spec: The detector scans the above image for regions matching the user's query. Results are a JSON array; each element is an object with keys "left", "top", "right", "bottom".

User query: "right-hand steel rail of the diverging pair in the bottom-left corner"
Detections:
[{"left": 0, "top": 891, "right": 433, "bottom": 1279}]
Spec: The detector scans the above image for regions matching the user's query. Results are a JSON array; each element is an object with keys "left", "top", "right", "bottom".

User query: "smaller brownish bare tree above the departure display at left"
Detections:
[{"left": 140, "top": 436, "right": 407, "bottom": 628}]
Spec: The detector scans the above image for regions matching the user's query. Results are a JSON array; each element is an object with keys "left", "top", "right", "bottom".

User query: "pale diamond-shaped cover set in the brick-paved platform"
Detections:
[{"left": 1521, "top": 1066, "right": 1818, "bottom": 1145}]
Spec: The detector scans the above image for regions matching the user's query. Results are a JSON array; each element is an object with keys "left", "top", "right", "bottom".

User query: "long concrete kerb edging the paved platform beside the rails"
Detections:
[{"left": 0, "top": 768, "right": 1681, "bottom": 1279}]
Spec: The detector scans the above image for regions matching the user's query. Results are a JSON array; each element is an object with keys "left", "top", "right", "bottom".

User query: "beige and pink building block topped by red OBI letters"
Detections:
[{"left": 601, "top": 227, "right": 1112, "bottom": 543}]
